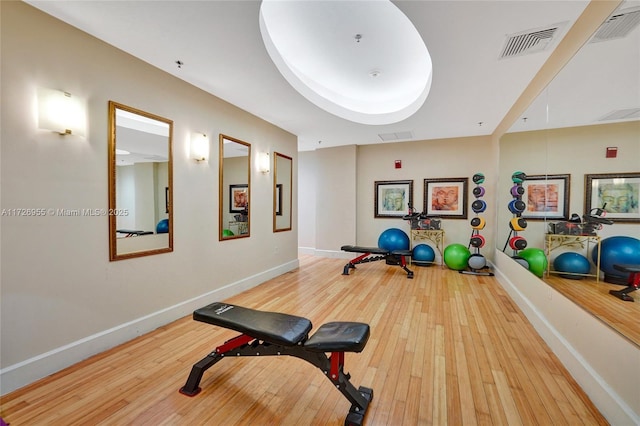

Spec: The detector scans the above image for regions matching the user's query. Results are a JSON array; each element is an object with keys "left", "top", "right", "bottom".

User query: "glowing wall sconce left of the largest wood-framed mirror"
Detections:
[{"left": 38, "top": 88, "right": 86, "bottom": 136}]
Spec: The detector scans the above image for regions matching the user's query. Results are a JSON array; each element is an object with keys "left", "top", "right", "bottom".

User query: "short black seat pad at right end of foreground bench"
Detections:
[{"left": 304, "top": 322, "right": 370, "bottom": 352}]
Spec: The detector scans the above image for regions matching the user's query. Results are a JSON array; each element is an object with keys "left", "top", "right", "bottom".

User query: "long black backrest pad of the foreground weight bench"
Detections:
[{"left": 193, "top": 302, "right": 312, "bottom": 346}]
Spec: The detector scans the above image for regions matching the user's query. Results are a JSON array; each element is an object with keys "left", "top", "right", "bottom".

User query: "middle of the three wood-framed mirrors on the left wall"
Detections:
[{"left": 218, "top": 134, "right": 251, "bottom": 241}]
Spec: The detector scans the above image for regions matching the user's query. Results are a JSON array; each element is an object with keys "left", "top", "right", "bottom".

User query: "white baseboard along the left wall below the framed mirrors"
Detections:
[{"left": 0, "top": 259, "right": 300, "bottom": 395}]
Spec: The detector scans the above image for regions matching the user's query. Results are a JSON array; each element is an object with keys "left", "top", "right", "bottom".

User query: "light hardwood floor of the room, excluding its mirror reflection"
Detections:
[{"left": 1, "top": 257, "right": 607, "bottom": 426}]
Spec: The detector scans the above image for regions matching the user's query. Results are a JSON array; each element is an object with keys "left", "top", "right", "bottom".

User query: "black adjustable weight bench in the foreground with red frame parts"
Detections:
[{"left": 180, "top": 302, "right": 373, "bottom": 426}]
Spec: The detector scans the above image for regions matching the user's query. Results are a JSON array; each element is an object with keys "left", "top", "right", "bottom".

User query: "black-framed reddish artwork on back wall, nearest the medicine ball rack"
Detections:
[{"left": 423, "top": 178, "right": 469, "bottom": 219}]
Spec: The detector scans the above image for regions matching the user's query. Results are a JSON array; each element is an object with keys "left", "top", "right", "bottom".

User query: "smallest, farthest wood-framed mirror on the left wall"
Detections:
[{"left": 273, "top": 152, "right": 293, "bottom": 232}]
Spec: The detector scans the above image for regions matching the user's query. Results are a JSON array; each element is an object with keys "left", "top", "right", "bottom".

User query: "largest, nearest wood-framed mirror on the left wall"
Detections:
[{"left": 108, "top": 101, "right": 173, "bottom": 261}]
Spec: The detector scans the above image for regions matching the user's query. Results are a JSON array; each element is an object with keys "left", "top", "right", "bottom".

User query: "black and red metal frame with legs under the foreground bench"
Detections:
[{"left": 180, "top": 334, "right": 373, "bottom": 426}]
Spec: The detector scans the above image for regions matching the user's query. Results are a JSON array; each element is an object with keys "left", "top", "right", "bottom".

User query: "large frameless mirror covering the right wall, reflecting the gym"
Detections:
[{"left": 497, "top": 2, "right": 640, "bottom": 346}]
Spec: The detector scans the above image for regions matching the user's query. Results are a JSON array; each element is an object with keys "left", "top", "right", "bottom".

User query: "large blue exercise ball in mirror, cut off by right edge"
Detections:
[{"left": 591, "top": 236, "right": 640, "bottom": 284}]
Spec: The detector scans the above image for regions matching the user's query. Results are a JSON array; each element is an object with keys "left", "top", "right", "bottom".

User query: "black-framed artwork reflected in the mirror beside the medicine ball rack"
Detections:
[{"left": 522, "top": 174, "right": 571, "bottom": 220}]
